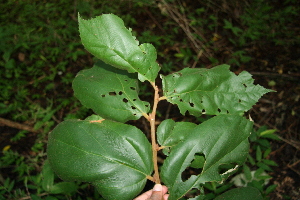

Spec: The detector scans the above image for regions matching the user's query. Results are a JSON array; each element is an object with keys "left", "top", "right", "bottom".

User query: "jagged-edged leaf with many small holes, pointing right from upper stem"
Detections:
[{"left": 162, "top": 65, "right": 271, "bottom": 116}]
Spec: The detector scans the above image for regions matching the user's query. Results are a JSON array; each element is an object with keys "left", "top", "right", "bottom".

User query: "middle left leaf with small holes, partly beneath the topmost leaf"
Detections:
[{"left": 73, "top": 62, "right": 149, "bottom": 122}]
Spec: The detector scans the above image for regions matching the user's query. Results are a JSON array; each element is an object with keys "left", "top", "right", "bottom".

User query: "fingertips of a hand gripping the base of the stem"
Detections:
[{"left": 134, "top": 184, "right": 169, "bottom": 200}]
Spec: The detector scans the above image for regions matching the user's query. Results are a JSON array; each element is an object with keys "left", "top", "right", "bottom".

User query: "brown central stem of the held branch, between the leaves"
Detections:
[{"left": 148, "top": 82, "right": 160, "bottom": 183}]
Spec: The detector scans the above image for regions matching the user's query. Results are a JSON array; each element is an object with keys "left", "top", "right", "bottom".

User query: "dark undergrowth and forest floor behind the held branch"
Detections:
[{"left": 0, "top": 0, "right": 300, "bottom": 199}]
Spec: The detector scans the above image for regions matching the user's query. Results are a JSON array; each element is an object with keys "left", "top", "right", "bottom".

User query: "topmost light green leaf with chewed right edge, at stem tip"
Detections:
[{"left": 78, "top": 14, "right": 160, "bottom": 82}]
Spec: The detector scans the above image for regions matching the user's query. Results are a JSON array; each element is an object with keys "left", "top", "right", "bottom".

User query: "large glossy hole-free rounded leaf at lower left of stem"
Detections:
[{"left": 48, "top": 120, "right": 153, "bottom": 200}]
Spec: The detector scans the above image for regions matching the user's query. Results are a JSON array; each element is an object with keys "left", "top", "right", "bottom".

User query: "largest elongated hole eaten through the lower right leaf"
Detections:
[{"left": 181, "top": 153, "right": 206, "bottom": 181}]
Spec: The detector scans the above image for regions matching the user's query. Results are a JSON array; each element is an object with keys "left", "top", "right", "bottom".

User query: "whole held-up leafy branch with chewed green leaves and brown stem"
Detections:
[{"left": 48, "top": 14, "right": 271, "bottom": 200}]
